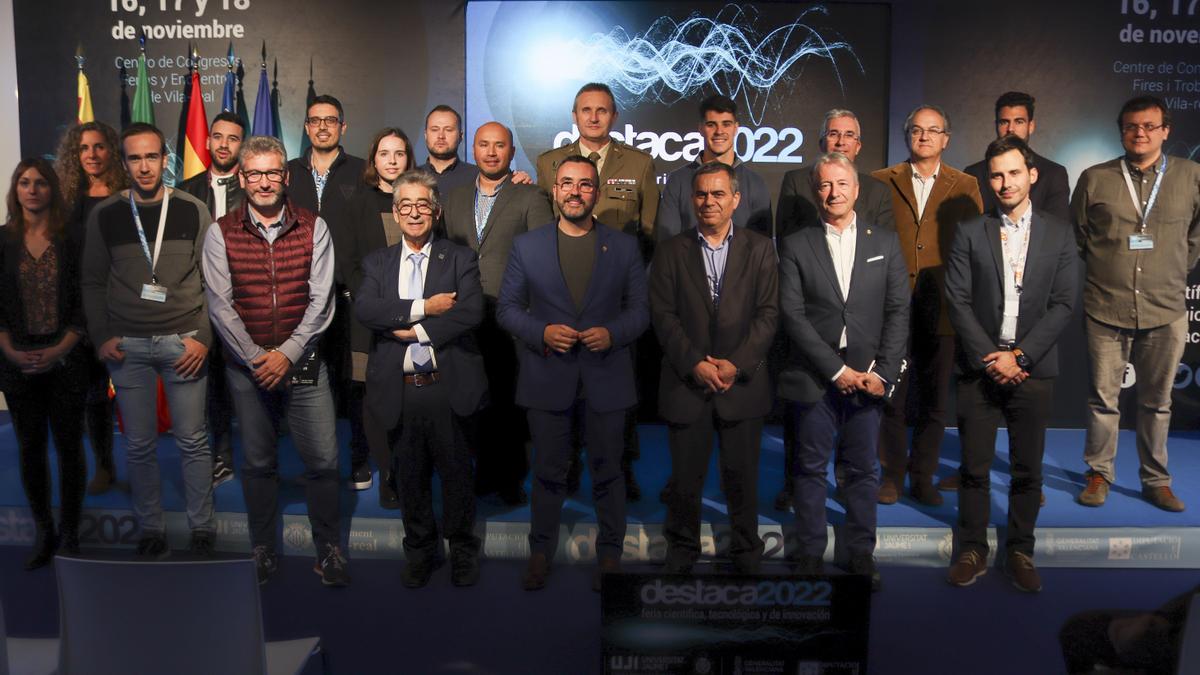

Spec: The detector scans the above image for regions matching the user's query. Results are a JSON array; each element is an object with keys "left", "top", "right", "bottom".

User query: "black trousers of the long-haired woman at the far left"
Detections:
[{"left": 5, "top": 371, "right": 88, "bottom": 533}]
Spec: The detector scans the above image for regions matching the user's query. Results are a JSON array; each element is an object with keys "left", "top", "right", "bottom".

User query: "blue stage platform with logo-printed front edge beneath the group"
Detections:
[{"left": 0, "top": 413, "right": 1200, "bottom": 568}]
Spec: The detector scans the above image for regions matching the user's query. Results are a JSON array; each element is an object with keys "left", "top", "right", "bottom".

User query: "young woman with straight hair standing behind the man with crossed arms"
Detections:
[{"left": 338, "top": 127, "right": 415, "bottom": 509}]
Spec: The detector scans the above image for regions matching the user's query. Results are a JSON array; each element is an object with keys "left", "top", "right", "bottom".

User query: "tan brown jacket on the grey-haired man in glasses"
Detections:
[{"left": 871, "top": 161, "right": 983, "bottom": 335}]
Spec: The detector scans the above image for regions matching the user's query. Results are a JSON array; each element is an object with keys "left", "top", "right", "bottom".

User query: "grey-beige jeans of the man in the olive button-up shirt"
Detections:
[{"left": 1084, "top": 316, "right": 1188, "bottom": 488}]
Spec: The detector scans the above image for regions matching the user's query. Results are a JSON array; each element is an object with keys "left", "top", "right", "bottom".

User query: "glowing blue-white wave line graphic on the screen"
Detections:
[{"left": 582, "top": 5, "right": 863, "bottom": 124}]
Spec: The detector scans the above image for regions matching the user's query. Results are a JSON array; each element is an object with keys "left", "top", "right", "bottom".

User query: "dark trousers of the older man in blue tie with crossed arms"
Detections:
[{"left": 398, "top": 374, "right": 480, "bottom": 562}]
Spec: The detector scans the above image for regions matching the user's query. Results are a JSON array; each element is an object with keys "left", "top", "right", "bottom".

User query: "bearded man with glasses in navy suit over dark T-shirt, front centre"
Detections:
[{"left": 497, "top": 155, "right": 649, "bottom": 591}]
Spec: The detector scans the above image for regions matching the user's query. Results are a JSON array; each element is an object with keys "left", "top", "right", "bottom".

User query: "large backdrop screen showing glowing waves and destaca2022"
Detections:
[{"left": 467, "top": 2, "right": 890, "bottom": 203}]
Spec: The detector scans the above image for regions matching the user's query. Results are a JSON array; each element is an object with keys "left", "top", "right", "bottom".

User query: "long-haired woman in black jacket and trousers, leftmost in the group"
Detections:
[{"left": 0, "top": 159, "right": 88, "bottom": 569}]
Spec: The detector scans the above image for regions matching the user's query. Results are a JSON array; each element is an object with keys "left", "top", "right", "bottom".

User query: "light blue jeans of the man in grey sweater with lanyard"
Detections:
[{"left": 108, "top": 333, "right": 215, "bottom": 534}]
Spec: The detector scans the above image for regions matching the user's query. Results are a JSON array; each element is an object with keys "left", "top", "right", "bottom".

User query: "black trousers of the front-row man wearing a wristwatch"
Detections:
[{"left": 956, "top": 377, "right": 1054, "bottom": 556}]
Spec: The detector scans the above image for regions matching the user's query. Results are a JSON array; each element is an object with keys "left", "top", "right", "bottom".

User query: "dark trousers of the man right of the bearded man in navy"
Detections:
[{"left": 662, "top": 400, "right": 763, "bottom": 571}]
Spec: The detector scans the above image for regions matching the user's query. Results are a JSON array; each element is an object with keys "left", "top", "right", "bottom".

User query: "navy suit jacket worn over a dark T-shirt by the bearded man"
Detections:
[{"left": 496, "top": 222, "right": 650, "bottom": 412}]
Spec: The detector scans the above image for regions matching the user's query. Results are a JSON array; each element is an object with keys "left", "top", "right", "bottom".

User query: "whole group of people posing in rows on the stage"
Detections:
[{"left": 0, "top": 83, "right": 1200, "bottom": 592}]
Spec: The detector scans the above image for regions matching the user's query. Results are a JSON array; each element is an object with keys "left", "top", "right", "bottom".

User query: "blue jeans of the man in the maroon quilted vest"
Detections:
[{"left": 226, "top": 360, "right": 341, "bottom": 551}]
